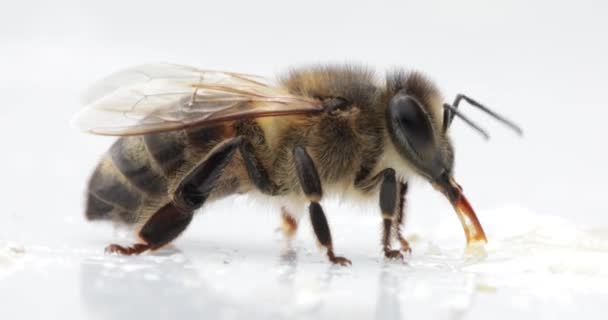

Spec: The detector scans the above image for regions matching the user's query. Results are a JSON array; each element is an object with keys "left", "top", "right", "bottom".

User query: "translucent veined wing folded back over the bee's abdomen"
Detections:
[{"left": 74, "top": 64, "right": 323, "bottom": 136}]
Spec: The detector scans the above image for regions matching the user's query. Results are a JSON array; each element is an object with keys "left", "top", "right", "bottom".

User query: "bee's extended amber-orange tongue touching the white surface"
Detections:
[{"left": 433, "top": 175, "right": 488, "bottom": 247}]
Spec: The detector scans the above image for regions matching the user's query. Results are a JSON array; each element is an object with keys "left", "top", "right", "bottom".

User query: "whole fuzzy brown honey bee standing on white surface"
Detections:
[{"left": 76, "top": 64, "right": 521, "bottom": 264}]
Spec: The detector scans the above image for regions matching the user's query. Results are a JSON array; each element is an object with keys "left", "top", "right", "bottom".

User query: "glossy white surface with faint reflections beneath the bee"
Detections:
[{"left": 0, "top": 198, "right": 608, "bottom": 319}]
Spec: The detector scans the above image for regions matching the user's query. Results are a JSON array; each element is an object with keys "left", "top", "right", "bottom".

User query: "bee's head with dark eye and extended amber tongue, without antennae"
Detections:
[{"left": 385, "top": 72, "right": 485, "bottom": 243}]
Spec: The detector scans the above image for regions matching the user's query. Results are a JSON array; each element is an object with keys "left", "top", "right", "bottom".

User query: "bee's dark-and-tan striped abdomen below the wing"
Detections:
[{"left": 86, "top": 124, "right": 234, "bottom": 223}]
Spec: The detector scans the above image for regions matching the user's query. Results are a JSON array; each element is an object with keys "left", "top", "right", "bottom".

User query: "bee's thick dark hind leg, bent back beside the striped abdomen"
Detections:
[{"left": 106, "top": 137, "right": 243, "bottom": 255}]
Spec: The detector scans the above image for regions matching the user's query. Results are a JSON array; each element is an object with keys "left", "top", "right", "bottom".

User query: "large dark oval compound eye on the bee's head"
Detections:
[{"left": 389, "top": 93, "right": 435, "bottom": 160}]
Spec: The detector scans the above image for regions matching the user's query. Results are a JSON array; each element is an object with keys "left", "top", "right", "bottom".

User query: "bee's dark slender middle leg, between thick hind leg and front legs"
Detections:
[{"left": 293, "top": 146, "right": 351, "bottom": 266}]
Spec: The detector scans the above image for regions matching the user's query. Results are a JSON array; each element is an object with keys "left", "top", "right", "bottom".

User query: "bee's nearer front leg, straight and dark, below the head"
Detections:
[{"left": 380, "top": 168, "right": 403, "bottom": 259}]
